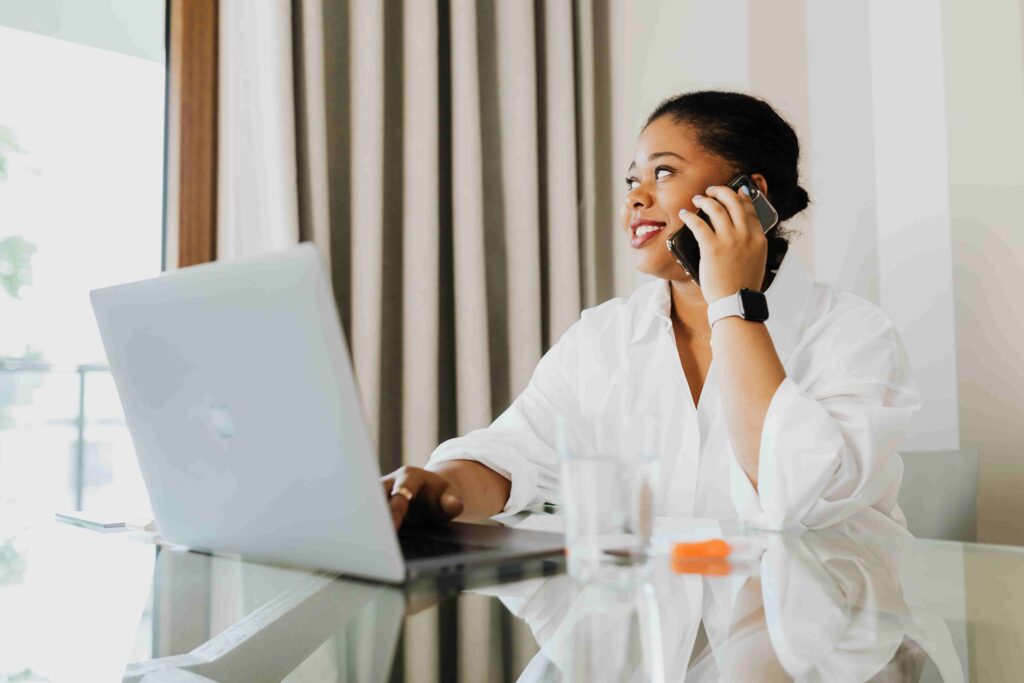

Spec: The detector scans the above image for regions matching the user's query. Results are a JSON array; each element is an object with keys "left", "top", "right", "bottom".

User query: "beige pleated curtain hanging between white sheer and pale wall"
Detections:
[{"left": 292, "top": 0, "right": 613, "bottom": 479}]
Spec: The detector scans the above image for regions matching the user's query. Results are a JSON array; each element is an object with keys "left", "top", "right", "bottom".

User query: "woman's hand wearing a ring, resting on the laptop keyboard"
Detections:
[{"left": 381, "top": 467, "right": 463, "bottom": 529}]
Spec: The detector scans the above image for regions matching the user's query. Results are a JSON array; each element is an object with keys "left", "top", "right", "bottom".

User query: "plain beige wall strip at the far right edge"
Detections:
[{"left": 942, "top": 0, "right": 1024, "bottom": 544}]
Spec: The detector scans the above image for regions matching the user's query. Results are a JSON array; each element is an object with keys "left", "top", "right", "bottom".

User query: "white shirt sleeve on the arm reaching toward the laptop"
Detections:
[{"left": 427, "top": 321, "right": 581, "bottom": 513}]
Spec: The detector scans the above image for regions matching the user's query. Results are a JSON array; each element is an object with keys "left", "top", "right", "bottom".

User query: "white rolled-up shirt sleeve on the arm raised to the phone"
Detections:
[{"left": 729, "top": 302, "right": 921, "bottom": 529}]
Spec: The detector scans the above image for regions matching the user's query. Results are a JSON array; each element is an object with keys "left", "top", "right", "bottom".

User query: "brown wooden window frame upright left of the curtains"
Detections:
[{"left": 164, "top": 0, "right": 219, "bottom": 269}]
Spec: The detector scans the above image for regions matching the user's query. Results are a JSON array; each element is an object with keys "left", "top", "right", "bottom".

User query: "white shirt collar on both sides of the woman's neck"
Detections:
[{"left": 630, "top": 254, "right": 814, "bottom": 359}]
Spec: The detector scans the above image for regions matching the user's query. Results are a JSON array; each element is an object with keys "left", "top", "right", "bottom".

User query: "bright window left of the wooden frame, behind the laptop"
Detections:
[{"left": 0, "top": 7, "right": 165, "bottom": 536}]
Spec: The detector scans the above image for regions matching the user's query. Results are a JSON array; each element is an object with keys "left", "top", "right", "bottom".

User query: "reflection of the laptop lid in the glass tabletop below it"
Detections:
[{"left": 124, "top": 548, "right": 406, "bottom": 683}]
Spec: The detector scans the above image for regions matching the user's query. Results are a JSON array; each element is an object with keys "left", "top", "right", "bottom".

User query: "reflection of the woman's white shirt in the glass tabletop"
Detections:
[{"left": 499, "top": 522, "right": 964, "bottom": 682}]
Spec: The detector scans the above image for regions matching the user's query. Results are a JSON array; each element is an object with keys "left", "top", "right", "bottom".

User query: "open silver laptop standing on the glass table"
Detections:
[{"left": 92, "top": 244, "right": 563, "bottom": 582}]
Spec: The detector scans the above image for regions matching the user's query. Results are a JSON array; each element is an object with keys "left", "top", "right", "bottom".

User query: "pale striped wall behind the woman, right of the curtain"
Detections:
[{"left": 609, "top": 0, "right": 1024, "bottom": 543}]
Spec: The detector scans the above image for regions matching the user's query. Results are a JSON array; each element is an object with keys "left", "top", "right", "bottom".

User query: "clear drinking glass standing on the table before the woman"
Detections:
[{"left": 558, "top": 414, "right": 659, "bottom": 581}]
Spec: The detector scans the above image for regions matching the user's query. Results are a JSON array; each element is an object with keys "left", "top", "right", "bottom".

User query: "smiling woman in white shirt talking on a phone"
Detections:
[{"left": 384, "top": 91, "right": 919, "bottom": 529}]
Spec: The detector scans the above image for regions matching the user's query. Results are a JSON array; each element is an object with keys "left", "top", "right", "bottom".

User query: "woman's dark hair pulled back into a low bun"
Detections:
[{"left": 643, "top": 90, "right": 810, "bottom": 229}]
